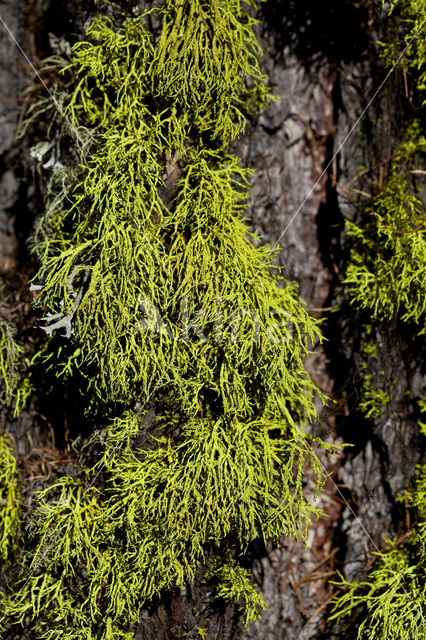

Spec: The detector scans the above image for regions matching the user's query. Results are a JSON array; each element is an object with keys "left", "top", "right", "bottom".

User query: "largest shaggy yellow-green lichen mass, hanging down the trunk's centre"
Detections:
[{"left": 4, "top": 0, "right": 333, "bottom": 640}]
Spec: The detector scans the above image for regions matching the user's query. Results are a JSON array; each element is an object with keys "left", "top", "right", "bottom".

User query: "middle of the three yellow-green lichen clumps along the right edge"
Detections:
[{"left": 345, "top": 123, "right": 426, "bottom": 333}]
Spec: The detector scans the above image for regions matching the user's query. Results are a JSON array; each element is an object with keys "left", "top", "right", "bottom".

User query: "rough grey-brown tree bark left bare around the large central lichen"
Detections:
[{"left": 0, "top": 0, "right": 421, "bottom": 640}]
